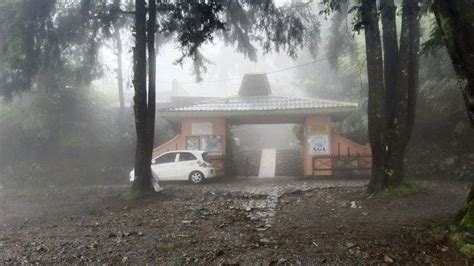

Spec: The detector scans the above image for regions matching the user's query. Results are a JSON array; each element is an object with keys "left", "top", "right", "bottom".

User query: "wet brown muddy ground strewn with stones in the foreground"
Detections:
[{"left": 0, "top": 178, "right": 472, "bottom": 265}]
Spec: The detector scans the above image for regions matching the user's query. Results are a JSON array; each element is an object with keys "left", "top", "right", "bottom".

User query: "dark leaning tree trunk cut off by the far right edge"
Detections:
[{"left": 433, "top": 0, "right": 474, "bottom": 231}]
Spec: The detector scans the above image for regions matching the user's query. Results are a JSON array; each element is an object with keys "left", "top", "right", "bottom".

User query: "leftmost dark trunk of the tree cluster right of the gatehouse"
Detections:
[{"left": 361, "top": 0, "right": 386, "bottom": 193}]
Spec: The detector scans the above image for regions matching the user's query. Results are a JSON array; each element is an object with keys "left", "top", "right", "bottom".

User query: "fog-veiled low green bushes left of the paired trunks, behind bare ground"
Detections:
[{"left": 0, "top": 87, "right": 128, "bottom": 185}]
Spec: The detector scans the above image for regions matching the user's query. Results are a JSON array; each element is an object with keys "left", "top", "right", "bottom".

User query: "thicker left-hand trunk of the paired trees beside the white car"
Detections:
[{"left": 133, "top": 0, "right": 151, "bottom": 192}]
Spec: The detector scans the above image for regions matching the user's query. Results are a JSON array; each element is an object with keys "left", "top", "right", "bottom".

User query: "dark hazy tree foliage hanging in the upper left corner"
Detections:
[{"left": 0, "top": 0, "right": 122, "bottom": 99}]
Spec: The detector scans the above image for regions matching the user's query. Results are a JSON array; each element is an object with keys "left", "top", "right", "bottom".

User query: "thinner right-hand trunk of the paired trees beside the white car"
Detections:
[{"left": 147, "top": 0, "right": 156, "bottom": 166}]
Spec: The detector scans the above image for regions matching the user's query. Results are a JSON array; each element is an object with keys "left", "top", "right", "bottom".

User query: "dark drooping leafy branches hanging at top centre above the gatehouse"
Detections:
[{"left": 158, "top": 0, "right": 320, "bottom": 78}]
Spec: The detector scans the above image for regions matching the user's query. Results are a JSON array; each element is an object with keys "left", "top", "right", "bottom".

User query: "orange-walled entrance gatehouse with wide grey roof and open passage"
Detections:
[{"left": 153, "top": 74, "right": 371, "bottom": 176}]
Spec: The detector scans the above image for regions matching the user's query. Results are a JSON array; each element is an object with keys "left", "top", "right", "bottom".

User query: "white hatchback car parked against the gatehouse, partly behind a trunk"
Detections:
[{"left": 130, "top": 150, "right": 216, "bottom": 184}]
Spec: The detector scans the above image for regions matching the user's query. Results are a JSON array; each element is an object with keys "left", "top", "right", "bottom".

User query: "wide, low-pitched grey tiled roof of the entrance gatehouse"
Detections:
[{"left": 166, "top": 95, "right": 357, "bottom": 112}]
